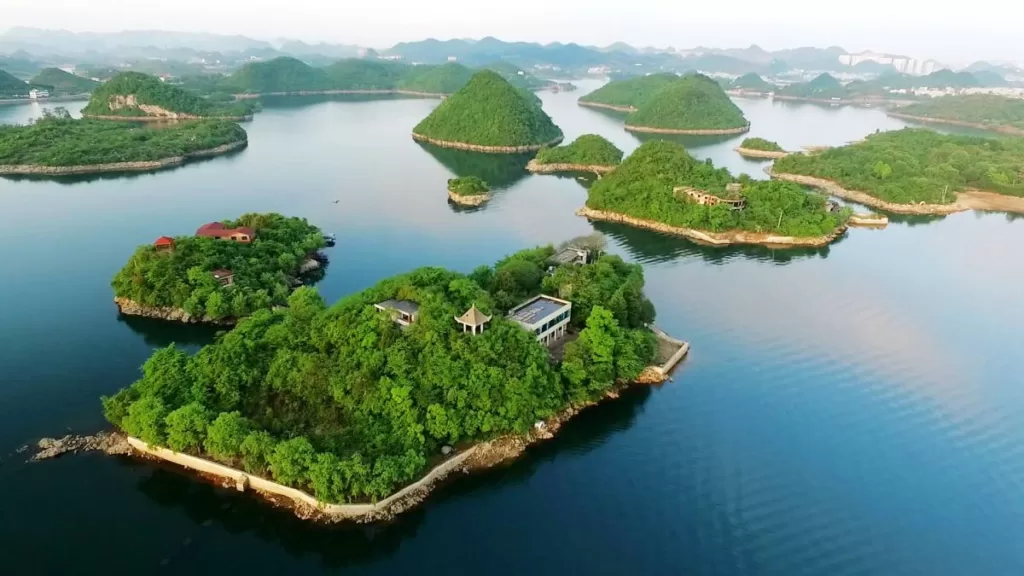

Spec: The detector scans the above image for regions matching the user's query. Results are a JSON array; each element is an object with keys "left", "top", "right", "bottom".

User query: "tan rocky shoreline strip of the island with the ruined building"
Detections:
[{"left": 577, "top": 206, "right": 847, "bottom": 248}]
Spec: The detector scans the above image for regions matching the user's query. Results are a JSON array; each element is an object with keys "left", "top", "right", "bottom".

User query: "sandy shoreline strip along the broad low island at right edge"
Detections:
[{"left": 765, "top": 167, "right": 1024, "bottom": 216}]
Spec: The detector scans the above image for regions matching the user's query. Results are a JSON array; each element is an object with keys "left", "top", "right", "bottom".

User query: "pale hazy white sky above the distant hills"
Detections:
[{"left": 6, "top": 0, "right": 1024, "bottom": 64}]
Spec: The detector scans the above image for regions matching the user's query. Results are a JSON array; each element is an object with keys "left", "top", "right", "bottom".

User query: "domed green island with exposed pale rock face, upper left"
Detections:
[{"left": 82, "top": 72, "right": 252, "bottom": 120}]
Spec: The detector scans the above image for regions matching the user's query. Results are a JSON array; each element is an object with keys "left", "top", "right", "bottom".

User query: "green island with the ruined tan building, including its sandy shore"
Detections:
[{"left": 579, "top": 139, "right": 850, "bottom": 246}]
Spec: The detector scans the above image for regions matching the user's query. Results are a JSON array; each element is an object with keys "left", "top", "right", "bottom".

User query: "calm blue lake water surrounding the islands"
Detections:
[{"left": 0, "top": 82, "right": 1024, "bottom": 576}]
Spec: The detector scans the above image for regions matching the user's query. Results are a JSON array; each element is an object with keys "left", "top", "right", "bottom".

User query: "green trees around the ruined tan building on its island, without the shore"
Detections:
[{"left": 587, "top": 139, "right": 849, "bottom": 237}]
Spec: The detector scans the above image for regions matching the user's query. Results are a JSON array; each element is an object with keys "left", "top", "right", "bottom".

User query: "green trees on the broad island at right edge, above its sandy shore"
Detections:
[{"left": 774, "top": 128, "right": 1024, "bottom": 204}]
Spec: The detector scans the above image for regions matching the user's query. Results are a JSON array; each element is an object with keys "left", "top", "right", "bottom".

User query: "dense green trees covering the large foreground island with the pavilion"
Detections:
[{"left": 103, "top": 247, "right": 656, "bottom": 502}]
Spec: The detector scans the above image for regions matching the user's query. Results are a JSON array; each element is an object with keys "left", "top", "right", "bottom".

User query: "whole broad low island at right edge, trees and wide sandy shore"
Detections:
[{"left": 771, "top": 128, "right": 1024, "bottom": 214}]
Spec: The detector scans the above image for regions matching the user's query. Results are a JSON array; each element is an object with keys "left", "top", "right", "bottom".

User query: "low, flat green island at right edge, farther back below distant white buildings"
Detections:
[{"left": 889, "top": 94, "right": 1024, "bottom": 135}]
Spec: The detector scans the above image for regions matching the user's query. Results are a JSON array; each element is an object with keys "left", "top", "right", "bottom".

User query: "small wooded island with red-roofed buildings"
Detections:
[{"left": 111, "top": 213, "right": 327, "bottom": 324}]
